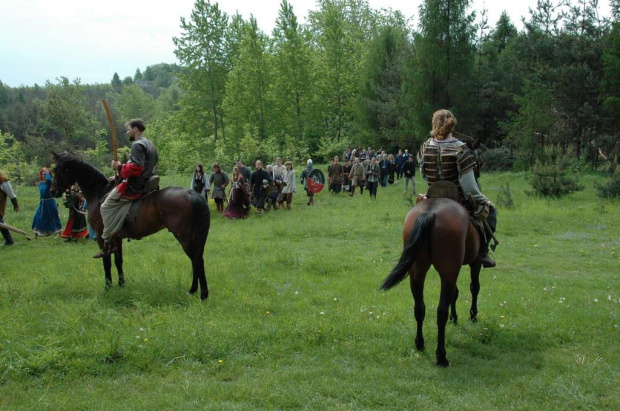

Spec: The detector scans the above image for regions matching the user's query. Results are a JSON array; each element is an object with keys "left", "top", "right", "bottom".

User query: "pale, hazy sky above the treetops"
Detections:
[{"left": 0, "top": 0, "right": 611, "bottom": 87}]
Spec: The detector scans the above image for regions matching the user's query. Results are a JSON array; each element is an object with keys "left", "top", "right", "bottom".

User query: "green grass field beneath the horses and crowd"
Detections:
[{"left": 0, "top": 173, "right": 620, "bottom": 410}]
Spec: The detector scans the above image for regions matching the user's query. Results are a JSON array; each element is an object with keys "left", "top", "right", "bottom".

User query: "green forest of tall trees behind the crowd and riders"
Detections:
[{"left": 0, "top": 0, "right": 620, "bottom": 182}]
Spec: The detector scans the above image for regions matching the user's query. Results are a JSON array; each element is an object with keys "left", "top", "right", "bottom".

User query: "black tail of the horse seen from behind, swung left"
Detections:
[{"left": 381, "top": 210, "right": 435, "bottom": 291}]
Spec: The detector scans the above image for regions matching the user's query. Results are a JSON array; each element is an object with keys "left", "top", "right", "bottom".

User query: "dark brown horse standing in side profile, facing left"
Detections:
[{"left": 51, "top": 153, "right": 211, "bottom": 300}]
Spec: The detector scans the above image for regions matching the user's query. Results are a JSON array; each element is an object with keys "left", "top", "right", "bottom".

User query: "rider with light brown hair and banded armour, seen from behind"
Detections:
[{"left": 418, "top": 110, "right": 497, "bottom": 268}]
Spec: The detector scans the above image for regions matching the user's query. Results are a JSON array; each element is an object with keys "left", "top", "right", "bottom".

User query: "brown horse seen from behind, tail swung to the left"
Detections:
[{"left": 381, "top": 183, "right": 482, "bottom": 367}]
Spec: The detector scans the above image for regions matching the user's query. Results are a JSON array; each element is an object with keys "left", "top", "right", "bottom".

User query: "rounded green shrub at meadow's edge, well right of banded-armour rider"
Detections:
[{"left": 530, "top": 146, "right": 583, "bottom": 198}]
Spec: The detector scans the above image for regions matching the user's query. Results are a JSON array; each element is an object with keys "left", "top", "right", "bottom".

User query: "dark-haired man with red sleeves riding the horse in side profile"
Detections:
[{"left": 93, "top": 119, "right": 158, "bottom": 258}]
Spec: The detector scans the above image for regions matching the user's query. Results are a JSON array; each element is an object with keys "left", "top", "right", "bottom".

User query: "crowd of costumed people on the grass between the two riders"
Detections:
[{"left": 183, "top": 147, "right": 416, "bottom": 219}]
